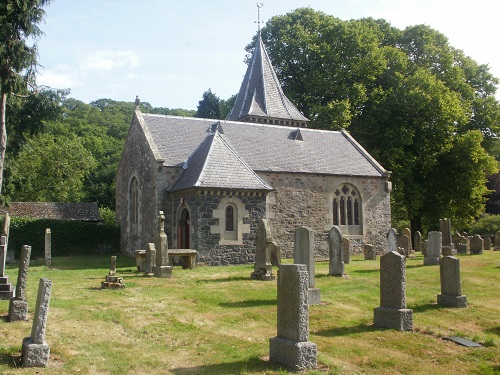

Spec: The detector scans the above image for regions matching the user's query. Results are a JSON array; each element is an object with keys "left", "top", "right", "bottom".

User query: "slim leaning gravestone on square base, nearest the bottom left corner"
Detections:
[{"left": 21, "top": 278, "right": 52, "bottom": 367}]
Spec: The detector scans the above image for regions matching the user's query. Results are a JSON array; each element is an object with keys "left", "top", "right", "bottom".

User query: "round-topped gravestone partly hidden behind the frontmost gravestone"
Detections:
[{"left": 293, "top": 227, "right": 321, "bottom": 305}]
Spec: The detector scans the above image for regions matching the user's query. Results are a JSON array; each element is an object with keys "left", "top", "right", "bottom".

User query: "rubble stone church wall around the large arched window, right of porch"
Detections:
[{"left": 259, "top": 172, "right": 391, "bottom": 258}]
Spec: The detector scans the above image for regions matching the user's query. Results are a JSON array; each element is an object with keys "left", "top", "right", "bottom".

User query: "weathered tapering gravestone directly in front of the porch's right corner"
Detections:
[{"left": 250, "top": 219, "right": 276, "bottom": 280}]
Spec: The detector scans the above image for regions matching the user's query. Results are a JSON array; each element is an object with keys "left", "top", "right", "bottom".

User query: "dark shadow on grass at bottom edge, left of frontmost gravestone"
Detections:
[{"left": 171, "top": 357, "right": 281, "bottom": 375}]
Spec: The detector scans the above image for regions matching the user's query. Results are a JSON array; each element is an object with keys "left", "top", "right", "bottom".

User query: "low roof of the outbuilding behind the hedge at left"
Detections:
[{"left": 0, "top": 202, "right": 102, "bottom": 222}]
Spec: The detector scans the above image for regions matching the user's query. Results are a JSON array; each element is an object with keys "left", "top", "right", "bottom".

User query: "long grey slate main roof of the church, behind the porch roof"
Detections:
[{"left": 136, "top": 111, "right": 387, "bottom": 178}]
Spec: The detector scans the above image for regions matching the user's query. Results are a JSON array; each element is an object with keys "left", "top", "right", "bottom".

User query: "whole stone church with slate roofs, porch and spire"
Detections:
[{"left": 116, "top": 36, "right": 391, "bottom": 265}]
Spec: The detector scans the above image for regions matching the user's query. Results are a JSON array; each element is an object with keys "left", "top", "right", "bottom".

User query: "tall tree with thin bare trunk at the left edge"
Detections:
[{"left": 0, "top": 0, "right": 50, "bottom": 198}]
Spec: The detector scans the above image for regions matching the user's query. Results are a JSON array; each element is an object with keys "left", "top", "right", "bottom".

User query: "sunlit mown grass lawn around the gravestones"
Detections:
[{"left": 0, "top": 251, "right": 500, "bottom": 375}]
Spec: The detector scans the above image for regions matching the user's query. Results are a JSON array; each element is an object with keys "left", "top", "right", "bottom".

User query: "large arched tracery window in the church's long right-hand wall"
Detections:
[{"left": 332, "top": 184, "right": 363, "bottom": 234}]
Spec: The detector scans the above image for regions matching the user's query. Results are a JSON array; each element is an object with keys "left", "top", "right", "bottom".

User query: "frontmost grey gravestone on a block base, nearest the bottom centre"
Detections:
[{"left": 269, "top": 264, "right": 317, "bottom": 371}]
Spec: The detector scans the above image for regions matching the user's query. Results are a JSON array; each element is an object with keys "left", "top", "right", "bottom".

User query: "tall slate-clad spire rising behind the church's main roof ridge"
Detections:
[{"left": 227, "top": 33, "right": 309, "bottom": 127}]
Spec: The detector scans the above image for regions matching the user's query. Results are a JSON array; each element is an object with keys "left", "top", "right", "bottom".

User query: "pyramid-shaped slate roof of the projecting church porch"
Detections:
[{"left": 170, "top": 122, "right": 273, "bottom": 192}]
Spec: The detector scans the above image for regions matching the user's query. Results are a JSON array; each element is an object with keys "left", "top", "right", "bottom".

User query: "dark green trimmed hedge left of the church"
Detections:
[{"left": 2, "top": 217, "right": 120, "bottom": 259}]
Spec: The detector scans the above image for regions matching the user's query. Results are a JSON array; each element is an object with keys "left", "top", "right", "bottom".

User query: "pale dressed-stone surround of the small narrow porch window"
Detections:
[{"left": 210, "top": 196, "right": 250, "bottom": 245}]
